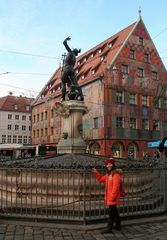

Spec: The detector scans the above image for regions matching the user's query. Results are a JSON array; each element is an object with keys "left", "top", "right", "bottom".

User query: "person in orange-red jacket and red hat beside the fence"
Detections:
[{"left": 92, "top": 158, "right": 122, "bottom": 233}]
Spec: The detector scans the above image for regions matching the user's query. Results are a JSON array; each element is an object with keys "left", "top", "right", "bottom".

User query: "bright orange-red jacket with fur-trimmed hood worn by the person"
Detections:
[{"left": 94, "top": 169, "right": 122, "bottom": 205}]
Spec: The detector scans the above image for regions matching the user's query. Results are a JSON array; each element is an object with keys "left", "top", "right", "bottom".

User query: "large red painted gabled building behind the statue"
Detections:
[{"left": 32, "top": 17, "right": 167, "bottom": 159}]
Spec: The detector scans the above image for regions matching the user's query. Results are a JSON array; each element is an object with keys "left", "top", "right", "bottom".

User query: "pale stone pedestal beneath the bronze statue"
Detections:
[{"left": 55, "top": 100, "right": 87, "bottom": 154}]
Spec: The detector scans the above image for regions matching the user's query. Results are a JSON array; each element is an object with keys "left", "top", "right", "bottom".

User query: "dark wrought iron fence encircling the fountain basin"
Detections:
[{"left": 0, "top": 156, "right": 167, "bottom": 222}]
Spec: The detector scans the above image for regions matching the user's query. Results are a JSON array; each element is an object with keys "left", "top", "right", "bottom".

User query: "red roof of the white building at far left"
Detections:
[{"left": 0, "top": 95, "right": 34, "bottom": 113}]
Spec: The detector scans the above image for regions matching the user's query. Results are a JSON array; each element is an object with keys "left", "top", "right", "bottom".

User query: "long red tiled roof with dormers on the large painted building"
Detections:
[{"left": 33, "top": 22, "right": 136, "bottom": 105}]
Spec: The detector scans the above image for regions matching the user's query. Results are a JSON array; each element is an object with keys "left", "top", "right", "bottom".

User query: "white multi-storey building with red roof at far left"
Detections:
[{"left": 0, "top": 95, "right": 34, "bottom": 144}]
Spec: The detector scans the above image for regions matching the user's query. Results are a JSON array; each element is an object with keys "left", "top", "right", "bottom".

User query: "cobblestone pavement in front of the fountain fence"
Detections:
[{"left": 0, "top": 221, "right": 167, "bottom": 240}]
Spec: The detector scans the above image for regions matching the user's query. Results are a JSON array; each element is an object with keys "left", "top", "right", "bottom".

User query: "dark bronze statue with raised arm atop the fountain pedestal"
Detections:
[{"left": 61, "top": 37, "right": 84, "bottom": 101}]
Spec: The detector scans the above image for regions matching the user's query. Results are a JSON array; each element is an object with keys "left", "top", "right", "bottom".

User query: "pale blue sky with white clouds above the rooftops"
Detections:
[{"left": 0, "top": 0, "right": 167, "bottom": 97}]
